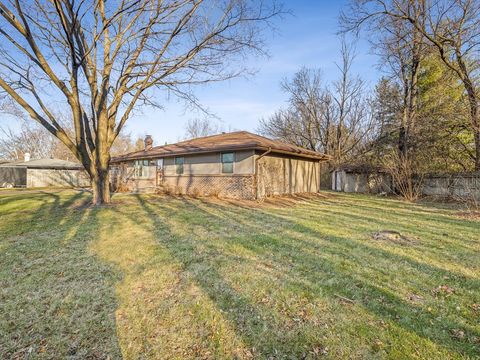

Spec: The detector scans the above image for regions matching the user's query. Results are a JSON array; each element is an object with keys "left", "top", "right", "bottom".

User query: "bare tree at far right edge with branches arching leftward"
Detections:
[{"left": 342, "top": 0, "right": 480, "bottom": 170}]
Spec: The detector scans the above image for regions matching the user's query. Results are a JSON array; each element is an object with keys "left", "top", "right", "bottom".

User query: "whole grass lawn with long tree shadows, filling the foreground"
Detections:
[{"left": 0, "top": 191, "right": 480, "bottom": 359}]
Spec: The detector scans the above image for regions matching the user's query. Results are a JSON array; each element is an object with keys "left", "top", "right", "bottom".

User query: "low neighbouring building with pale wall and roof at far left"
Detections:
[{"left": 0, "top": 154, "right": 90, "bottom": 188}]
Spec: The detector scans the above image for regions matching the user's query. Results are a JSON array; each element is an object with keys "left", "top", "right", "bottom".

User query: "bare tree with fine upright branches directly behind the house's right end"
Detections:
[{"left": 259, "top": 41, "right": 373, "bottom": 164}]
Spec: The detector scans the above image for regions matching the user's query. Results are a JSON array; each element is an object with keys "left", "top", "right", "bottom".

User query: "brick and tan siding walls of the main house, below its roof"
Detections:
[{"left": 111, "top": 150, "right": 320, "bottom": 199}]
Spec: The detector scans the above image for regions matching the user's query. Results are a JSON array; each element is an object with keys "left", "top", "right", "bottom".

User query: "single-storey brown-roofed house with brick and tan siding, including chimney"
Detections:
[{"left": 111, "top": 131, "right": 329, "bottom": 199}]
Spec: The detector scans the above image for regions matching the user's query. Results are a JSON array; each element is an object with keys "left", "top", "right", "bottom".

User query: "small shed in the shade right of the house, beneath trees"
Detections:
[{"left": 331, "top": 165, "right": 393, "bottom": 194}]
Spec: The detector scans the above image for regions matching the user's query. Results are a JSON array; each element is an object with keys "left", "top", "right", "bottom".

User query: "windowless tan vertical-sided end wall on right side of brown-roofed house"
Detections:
[{"left": 256, "top": 154, "right": 321, "bottom": 198}]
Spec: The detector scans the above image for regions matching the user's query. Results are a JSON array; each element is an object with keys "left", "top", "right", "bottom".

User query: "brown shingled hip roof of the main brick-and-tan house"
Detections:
[{"left": 112, "top": 131, "right": 329, "bottom": 162}]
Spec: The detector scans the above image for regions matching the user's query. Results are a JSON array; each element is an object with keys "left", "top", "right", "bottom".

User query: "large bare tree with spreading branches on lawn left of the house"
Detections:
[{"left": 0, "top": 0, "right": 280, "bottom": 204}]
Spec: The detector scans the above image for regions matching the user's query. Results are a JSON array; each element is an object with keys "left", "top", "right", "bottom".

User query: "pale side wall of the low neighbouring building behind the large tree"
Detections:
[{"left": 27, "top": 169, "right": 90, "bottom": 188}]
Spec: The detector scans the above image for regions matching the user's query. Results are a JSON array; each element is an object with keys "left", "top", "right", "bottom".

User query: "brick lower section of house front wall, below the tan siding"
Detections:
[{"left": 159, "top": 175, "right": 255, "bottom": 199}]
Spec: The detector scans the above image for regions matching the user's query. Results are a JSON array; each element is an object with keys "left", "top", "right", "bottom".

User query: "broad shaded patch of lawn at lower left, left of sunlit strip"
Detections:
[{"left": 0, "top": 192, "right": 120, "bottom": 359}]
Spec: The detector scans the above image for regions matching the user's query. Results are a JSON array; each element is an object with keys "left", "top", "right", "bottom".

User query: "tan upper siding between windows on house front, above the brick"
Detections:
[{"left": 163, "top": 150, "right": 254, "bottom": 176}]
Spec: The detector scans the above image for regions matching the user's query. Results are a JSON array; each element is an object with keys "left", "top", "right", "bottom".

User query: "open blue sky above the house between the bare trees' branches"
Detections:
[{"left": 0, "top": 0, "right": 379, "bottom": 145}]
